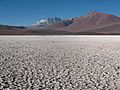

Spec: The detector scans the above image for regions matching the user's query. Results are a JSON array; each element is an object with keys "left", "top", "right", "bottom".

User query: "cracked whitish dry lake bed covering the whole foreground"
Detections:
[{"left": 0, "top": 36, "right": 120, "bottom": 90}]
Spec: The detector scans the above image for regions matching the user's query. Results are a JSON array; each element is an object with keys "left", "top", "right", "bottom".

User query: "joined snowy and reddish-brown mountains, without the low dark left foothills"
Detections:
[{"left": 27, "top": 11, "right": 120, "bottom": 33}]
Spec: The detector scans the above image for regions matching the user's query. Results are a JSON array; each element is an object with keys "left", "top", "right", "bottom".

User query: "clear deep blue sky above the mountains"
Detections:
[{"left": 0, "top": 0, "right": 120, "bottom": 25}]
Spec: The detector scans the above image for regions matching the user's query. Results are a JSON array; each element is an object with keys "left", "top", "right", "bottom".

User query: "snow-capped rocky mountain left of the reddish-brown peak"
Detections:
[{"left": 32, "top": 17, "right": 72, "bottom": 29}]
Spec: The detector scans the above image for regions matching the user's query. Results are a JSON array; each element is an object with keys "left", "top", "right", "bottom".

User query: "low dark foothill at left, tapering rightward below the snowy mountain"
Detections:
[{"left": 0, "top": 25, "right": 72, "bottom": 35}]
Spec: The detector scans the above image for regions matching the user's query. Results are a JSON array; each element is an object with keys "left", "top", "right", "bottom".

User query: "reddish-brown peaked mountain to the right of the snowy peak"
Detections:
[{"left": 61, "top": 12, "right": 120, "bottom": 32}]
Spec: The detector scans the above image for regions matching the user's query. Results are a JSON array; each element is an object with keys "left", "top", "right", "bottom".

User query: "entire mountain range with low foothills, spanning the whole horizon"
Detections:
[{"left": 0, "top": 11, "right": 120, "bottom": 35}]
